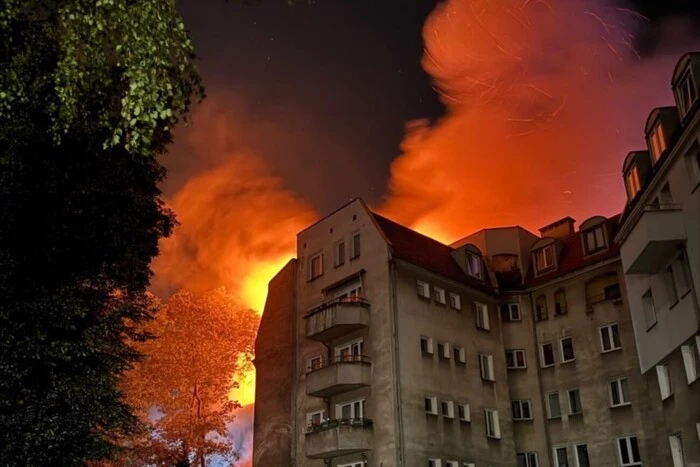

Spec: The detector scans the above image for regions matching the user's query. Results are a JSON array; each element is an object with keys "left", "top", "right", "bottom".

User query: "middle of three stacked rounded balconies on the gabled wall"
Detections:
[{"left": 306, "top": 355, "right": 372, "bottom": 397}]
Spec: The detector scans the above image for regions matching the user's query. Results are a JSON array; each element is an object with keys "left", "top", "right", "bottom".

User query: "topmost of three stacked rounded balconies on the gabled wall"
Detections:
[{"left": 304, "top": 297, "right": 369, "bottom": 342}]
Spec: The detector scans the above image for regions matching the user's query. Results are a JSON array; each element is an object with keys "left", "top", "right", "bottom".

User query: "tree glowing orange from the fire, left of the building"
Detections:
[{"left": 119, "top": 288, "right": 259, "bottom": 466}]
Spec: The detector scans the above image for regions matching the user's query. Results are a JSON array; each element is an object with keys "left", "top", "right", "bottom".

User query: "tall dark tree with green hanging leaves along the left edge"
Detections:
[{"left": 0, "top": 0, "right": 202, "bottom": 466}]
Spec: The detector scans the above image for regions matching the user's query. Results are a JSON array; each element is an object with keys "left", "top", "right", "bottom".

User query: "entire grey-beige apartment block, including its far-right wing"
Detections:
[{"left": 254, "top": 55, "right": 700, "bottom": 467}]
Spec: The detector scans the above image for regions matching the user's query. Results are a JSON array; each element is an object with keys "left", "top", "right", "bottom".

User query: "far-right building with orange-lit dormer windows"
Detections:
[{"left": 616, "top": 53, "right": 700, "bottom": 467}]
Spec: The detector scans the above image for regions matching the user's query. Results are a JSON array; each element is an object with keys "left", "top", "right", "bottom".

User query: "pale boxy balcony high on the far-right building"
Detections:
[{"left": 620, "top": 204, "right": 687, "bottom": 274}]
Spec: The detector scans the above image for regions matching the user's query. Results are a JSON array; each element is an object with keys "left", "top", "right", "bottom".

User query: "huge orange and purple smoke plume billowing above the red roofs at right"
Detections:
[{"left": 382, "top": 0, "right": 687, "bottom": 241}]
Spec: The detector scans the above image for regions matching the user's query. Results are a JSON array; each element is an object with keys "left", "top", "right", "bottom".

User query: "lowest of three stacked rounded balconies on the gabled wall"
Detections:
[{"left": 306, "top": 418, "right": 373, "bottom": 459}]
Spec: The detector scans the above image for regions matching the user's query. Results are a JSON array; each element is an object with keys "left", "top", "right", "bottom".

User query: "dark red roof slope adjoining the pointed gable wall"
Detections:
[{"left": 372, "top": 213, "right": 494, "bottom": 293}]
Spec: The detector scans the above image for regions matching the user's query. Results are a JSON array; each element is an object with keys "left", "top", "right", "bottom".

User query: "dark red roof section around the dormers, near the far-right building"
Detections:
[{"left": 525, "top": 214, "right": 621, "bottom": 286}]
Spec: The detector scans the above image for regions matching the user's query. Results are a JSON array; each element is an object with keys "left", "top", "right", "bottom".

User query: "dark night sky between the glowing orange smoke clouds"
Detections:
[{"left": 170, "top": 0, "right": 700, "bottom": 213}]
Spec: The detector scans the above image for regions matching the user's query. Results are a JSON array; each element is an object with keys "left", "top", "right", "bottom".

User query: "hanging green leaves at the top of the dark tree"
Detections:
[{"left": 0, "top": 0, "right": 203, "bottom": 155}]
